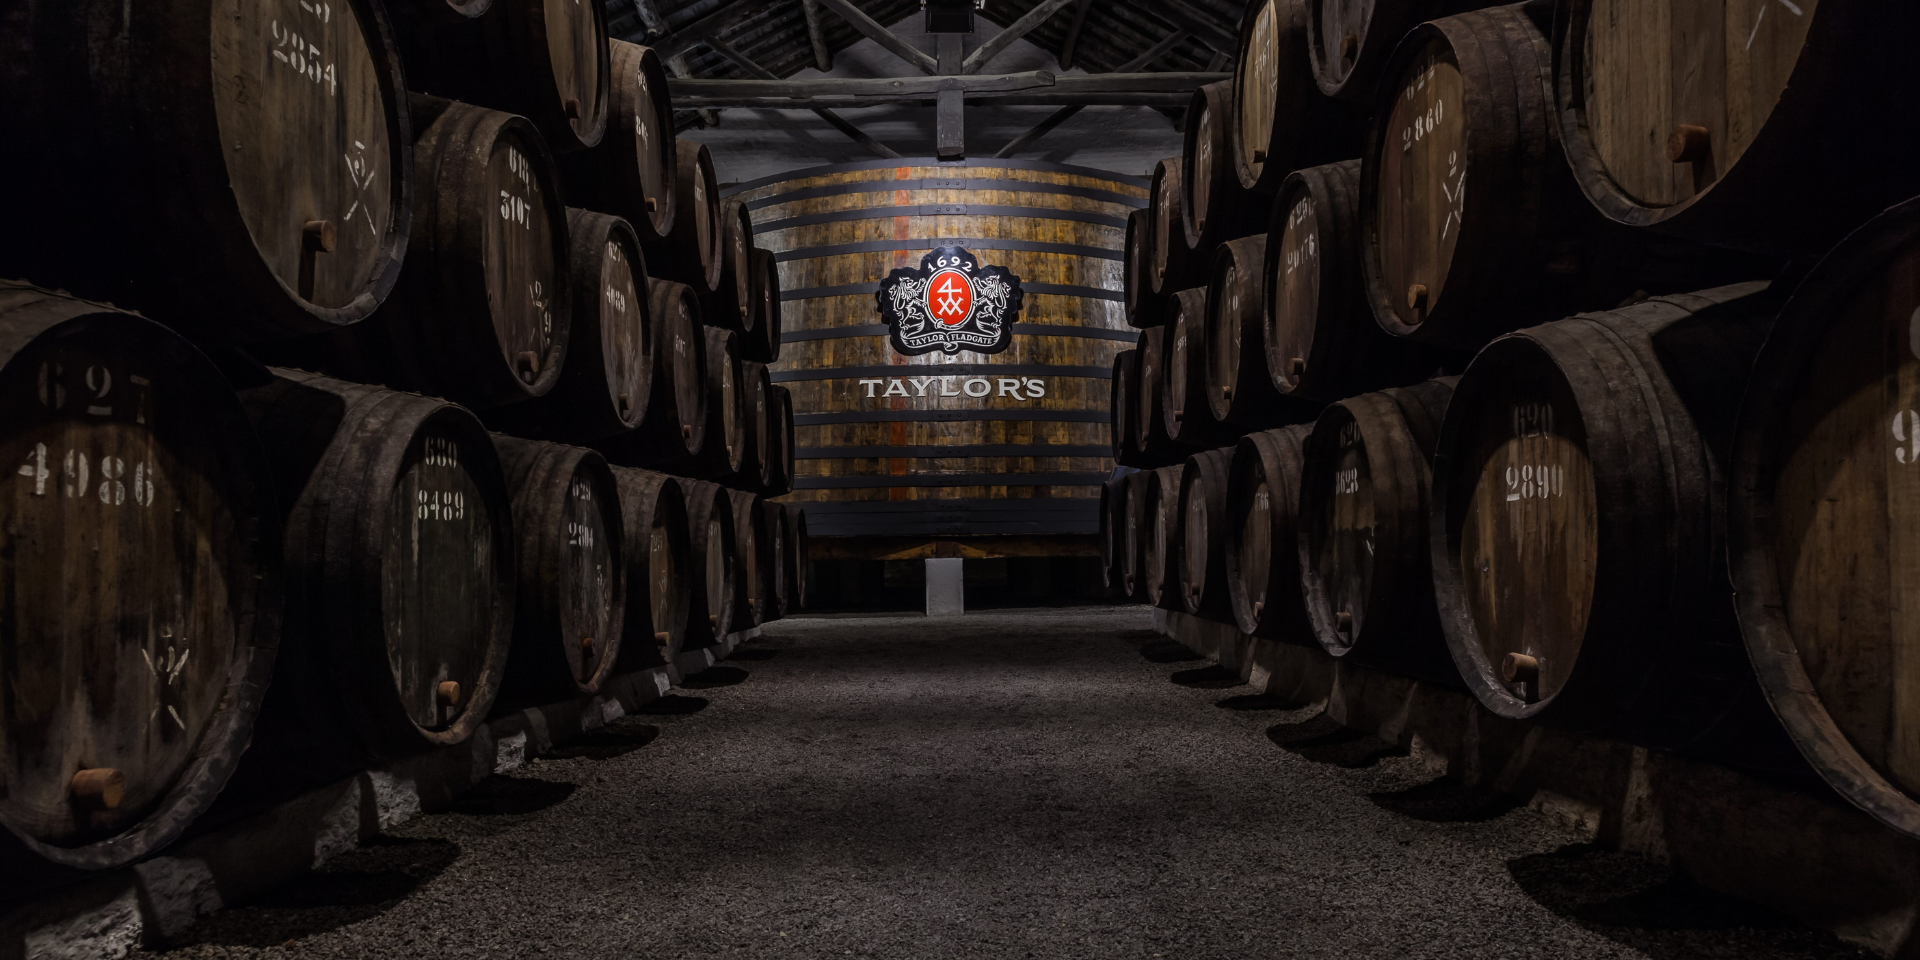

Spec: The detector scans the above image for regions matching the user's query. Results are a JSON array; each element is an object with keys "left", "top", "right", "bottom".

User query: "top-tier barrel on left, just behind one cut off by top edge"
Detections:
[{"left": 561, "top": 40, "right": 680, "bottom": 246}]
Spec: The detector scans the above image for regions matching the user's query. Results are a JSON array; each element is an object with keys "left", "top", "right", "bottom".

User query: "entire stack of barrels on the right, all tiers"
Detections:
[{"left": 1100, "top": 0, "right": 1920, "bottom": 835}]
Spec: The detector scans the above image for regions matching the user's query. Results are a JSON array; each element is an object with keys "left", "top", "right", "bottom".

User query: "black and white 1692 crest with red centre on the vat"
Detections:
[{"left": 874, "top": 246, "right": 1023, "bottom": 355}]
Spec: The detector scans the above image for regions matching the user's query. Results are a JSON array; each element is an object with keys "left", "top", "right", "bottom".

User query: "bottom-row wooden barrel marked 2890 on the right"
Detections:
[{"left": 1430, "top": 282, "right": 1791, "bottom": 753}]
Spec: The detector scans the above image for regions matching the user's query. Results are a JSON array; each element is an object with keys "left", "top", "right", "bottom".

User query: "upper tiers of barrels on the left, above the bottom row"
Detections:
[{"left": 0, "top": 0, "right": 791, "bottom": 493}]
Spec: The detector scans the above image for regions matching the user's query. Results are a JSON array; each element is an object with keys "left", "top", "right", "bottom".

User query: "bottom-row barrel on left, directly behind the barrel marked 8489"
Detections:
[{"left": 493, "top": 436, "right": 626, "bottom": 712}]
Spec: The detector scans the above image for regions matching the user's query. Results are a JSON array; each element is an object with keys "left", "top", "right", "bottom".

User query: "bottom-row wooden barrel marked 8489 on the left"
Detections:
[{"left": 242, "top": 369, "right": 516, "bottom": 764}]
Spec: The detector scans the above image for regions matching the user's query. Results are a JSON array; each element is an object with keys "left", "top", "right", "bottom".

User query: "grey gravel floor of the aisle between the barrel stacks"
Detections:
[{"left": 145, "top": 609, "right": 1860, "bottom": 960}]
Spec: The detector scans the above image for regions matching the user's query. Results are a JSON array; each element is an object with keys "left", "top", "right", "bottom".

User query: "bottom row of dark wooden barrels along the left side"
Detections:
[{"left": 0, "top": 280, "right": 806, "bottom": 893}]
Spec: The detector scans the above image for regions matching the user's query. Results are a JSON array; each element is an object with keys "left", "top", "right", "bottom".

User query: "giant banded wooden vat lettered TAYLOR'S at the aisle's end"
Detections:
[{"left": 726, "top": 159, "right": 1148, "bottom": 555}]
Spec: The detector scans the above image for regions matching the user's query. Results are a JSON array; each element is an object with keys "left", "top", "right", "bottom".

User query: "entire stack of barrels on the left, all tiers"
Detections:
[{"left": 0, "top": 0, "right": 806, "bottom": 883}]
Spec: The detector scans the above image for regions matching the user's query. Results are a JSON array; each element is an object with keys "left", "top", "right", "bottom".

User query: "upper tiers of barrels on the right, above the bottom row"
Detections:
[{"left": 1125, "top": 0, "right": 1920, "bottom": 393}]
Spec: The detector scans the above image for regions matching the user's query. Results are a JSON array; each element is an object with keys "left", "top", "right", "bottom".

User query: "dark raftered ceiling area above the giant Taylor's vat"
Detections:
[{"left": 607, "top": 0, "right": 1240, "bottom": 182}]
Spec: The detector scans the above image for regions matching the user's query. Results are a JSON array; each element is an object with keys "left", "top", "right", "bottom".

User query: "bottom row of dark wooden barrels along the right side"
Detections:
[{"left": 1102, "top": 192, "right": 1920, "bottom": 835}]
